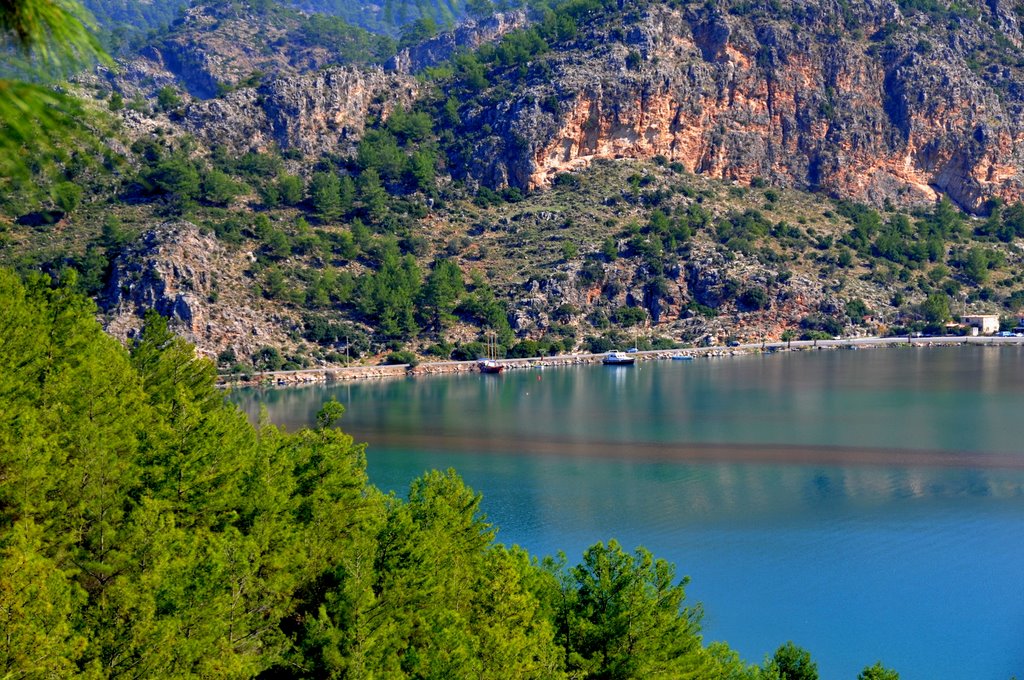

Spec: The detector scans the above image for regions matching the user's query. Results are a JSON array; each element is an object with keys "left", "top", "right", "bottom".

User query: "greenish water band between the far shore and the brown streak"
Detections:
[{"left": 234, "top": 347, "right": 1024, "bottom": 454}]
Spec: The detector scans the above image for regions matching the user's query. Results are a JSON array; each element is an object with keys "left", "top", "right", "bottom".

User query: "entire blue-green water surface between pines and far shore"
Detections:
[{"left": 232, "top": 347, "right": 1024, "bottom": 680}]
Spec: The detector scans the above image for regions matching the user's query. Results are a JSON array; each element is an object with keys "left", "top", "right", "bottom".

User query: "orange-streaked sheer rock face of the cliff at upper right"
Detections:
[{"left": 510, "top": 9, "right": 1024, "bottom": 210}]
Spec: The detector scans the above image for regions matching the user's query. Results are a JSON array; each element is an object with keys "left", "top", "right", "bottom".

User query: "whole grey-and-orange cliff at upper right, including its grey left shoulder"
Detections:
[{"left": 463, "top": 0, "right": 1024, "bottom": 211}]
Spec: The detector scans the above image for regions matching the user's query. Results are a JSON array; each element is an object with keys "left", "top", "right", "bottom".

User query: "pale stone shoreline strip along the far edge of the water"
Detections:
[{"left": 217, "top": 336, "right": 1024, "bottom": 387}]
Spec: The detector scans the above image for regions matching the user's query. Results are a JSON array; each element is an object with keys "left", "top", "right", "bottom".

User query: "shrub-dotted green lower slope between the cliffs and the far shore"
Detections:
[{"left": 4, "top": 120, "right": 1024, "bottom": 372}]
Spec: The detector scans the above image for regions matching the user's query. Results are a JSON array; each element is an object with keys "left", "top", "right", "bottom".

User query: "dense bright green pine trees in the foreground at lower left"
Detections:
[{"left": 0, "top": 270, "right": 895, "bottom": 679}]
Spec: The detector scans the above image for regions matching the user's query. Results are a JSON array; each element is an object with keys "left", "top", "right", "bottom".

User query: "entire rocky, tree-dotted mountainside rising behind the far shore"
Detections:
[{"left": 8, "top": 0, "right": 1024, "bottom": 366}]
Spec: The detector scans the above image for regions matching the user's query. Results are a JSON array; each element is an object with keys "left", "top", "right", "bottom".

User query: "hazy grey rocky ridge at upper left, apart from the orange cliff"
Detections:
[{"left": 104, "top": 3, "right": 527, "bottom": 160}]
